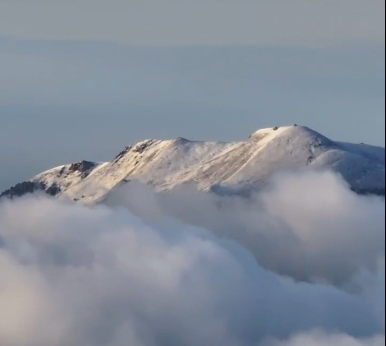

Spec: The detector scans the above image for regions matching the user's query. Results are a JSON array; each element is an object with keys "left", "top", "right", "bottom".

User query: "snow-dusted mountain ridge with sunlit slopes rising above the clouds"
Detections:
[{"left": 2, "top": 125, "right": 385, "bottom": 204}]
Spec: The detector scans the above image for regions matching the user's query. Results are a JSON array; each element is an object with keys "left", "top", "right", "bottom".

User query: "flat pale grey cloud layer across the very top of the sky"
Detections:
[{"left": 0, "top": 0, "right": 385, "bottom": 45}]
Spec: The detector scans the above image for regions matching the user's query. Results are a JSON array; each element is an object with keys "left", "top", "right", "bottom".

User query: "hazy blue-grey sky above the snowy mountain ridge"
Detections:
[{"left": 0, "top": 0, "right": 385, "bottom": 190}]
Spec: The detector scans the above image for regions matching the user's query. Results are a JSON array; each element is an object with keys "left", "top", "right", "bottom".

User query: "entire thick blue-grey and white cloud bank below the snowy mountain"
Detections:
[{"left": 0, "top": 174, "right": 384, "bottom": 346}]
